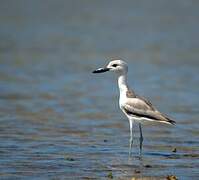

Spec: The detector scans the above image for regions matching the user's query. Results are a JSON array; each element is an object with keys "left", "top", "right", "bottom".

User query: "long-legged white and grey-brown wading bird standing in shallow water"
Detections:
[{"left": 92, "top": 59, "right": 176, "bottom": 157}]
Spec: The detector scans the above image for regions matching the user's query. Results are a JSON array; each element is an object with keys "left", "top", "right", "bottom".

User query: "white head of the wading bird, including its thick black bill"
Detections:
[{"left": 93, "top": 60, "right": 128, "bottom": 74}]
